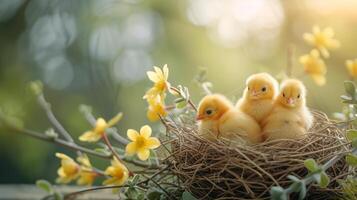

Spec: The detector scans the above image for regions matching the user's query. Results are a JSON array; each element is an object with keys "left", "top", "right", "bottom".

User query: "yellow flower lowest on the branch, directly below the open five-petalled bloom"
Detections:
[{"left": 103, "top": 157, "right": 129, "bottom": 186}]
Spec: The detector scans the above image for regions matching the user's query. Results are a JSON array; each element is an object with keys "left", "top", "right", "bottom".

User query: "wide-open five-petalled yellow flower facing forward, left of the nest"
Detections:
[{"left": 125, "top": 125, "right": 160, "bottom": 160}]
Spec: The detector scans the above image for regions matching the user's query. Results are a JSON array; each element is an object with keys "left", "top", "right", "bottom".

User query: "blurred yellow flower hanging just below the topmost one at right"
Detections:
[{"left": 300, "top": 49, "right": 327, "bottom": 86}]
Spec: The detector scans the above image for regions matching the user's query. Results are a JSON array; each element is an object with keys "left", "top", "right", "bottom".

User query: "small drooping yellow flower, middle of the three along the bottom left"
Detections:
[{"left": 77, "top": 154, "right": 98, "bottom": 186}]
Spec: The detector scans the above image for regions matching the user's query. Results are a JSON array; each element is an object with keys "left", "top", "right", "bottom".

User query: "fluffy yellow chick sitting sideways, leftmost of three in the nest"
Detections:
[{"left": 197, "top": 94, "right": 263, "bottom": 143}]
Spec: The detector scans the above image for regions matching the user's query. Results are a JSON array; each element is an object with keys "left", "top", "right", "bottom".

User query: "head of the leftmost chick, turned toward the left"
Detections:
[{"left": 196, "top": 94, "right": 233, "bottom": 120}]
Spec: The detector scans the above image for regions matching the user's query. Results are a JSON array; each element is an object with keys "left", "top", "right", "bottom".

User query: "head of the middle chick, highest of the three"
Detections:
[{"left": 244, "top": 73, "right": 278, "bottom": 100}]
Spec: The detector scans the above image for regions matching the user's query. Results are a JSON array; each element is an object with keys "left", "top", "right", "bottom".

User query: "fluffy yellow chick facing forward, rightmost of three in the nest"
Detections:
[{"left": 263, "top": 79, "right": 313, "bottom": 140}]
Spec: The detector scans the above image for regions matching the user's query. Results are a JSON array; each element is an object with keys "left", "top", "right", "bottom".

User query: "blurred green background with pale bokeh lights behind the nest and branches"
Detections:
[{"left": 0, "top": 0, "right": 357, "bottom": 183}]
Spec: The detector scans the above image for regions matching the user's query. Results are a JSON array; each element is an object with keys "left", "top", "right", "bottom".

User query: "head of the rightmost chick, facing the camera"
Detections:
[{"left": 277, "top": 79, "right": 306, "bottom": 108}]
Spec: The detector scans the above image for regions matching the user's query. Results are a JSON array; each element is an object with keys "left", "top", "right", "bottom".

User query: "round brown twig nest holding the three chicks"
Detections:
[{"left": 167, "top": 111, "right": 351, "bottom": 199}]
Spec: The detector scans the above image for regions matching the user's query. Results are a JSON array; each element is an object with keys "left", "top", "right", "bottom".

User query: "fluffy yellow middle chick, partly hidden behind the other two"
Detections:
[{"left": 236, "top": 73, "right": 278, "bottom": 123}]
